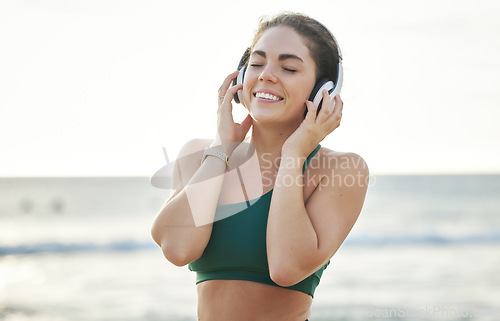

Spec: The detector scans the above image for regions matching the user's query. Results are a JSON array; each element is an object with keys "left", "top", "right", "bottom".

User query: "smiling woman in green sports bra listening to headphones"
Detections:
[{"left": 152, "top": 14, "right": 368, "bottom": 321}]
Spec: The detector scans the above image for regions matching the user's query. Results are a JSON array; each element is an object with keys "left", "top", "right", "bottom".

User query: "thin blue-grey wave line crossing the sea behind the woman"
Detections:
[{"left": 0, "top": 232, "right": 500, "bottom": 255}]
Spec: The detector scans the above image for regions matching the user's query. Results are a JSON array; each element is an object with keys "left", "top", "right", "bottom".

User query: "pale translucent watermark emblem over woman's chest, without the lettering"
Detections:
[{"left": 150, "top": 143, "right": 263, "bottom": 226}]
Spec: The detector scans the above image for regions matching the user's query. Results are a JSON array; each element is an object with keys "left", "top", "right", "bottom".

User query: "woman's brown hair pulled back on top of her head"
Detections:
[{"left": 249, "top": 13, "right": 342, "bottom": 81}]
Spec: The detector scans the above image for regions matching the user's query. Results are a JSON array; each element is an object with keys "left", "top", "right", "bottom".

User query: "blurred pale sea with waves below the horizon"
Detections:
[{"left": 0, "top": 175, "right": 500, "bottom": 321}]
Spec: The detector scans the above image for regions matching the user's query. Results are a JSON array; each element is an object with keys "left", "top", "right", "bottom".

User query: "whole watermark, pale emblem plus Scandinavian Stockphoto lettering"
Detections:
[{"left": 151, "top": 142, "right": 374, "bottom": 226}]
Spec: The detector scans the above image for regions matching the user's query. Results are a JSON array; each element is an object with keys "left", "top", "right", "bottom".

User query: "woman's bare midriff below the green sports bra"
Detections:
[{"left": 197, "top": 280, "right": 312, "bottom": 321}]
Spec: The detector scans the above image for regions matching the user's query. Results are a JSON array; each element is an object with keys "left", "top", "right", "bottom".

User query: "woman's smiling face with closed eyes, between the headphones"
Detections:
[{"left": 243, "top": 26, "right": 316, "bottom": 122}]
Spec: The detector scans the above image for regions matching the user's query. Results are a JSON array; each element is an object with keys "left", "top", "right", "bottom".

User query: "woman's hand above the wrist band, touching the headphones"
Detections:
[{"left": 214, "top": 71, "right": 252, "bottom": 156}]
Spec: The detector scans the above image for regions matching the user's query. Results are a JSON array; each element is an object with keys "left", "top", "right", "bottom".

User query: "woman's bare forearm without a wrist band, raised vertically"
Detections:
[{"left": 267, "top": 155, "right": 319, "bottom": 276}]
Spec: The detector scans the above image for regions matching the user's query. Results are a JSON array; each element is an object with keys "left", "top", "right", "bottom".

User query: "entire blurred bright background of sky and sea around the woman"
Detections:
[{"left": 0, "top": 0, "right": 500, "bottom": 321}]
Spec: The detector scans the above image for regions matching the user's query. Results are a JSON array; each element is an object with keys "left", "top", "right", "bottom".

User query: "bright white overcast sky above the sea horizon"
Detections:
[{"left": 0, "top": 0, "right": 500, "bottom": 176}]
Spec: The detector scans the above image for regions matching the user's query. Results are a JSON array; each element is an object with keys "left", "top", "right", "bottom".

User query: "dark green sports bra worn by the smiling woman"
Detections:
[{"left": 188, "top": 144, "right": 330, "bottom": 296}]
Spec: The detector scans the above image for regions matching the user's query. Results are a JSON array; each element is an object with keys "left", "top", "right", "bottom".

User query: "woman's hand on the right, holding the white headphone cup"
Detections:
[{"left": 282, "top": 90, "right": 344, "bottom": 157}]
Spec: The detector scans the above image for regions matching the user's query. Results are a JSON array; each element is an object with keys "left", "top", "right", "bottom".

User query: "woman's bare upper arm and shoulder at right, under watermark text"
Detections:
[{"left": 306, "top": 153, "right": 369, "bottom": 270}]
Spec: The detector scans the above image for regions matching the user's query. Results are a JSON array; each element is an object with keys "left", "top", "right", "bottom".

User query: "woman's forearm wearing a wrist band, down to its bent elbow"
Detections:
[{"left": 152, "top": 156, "right": 226, "bottom": 265}]
